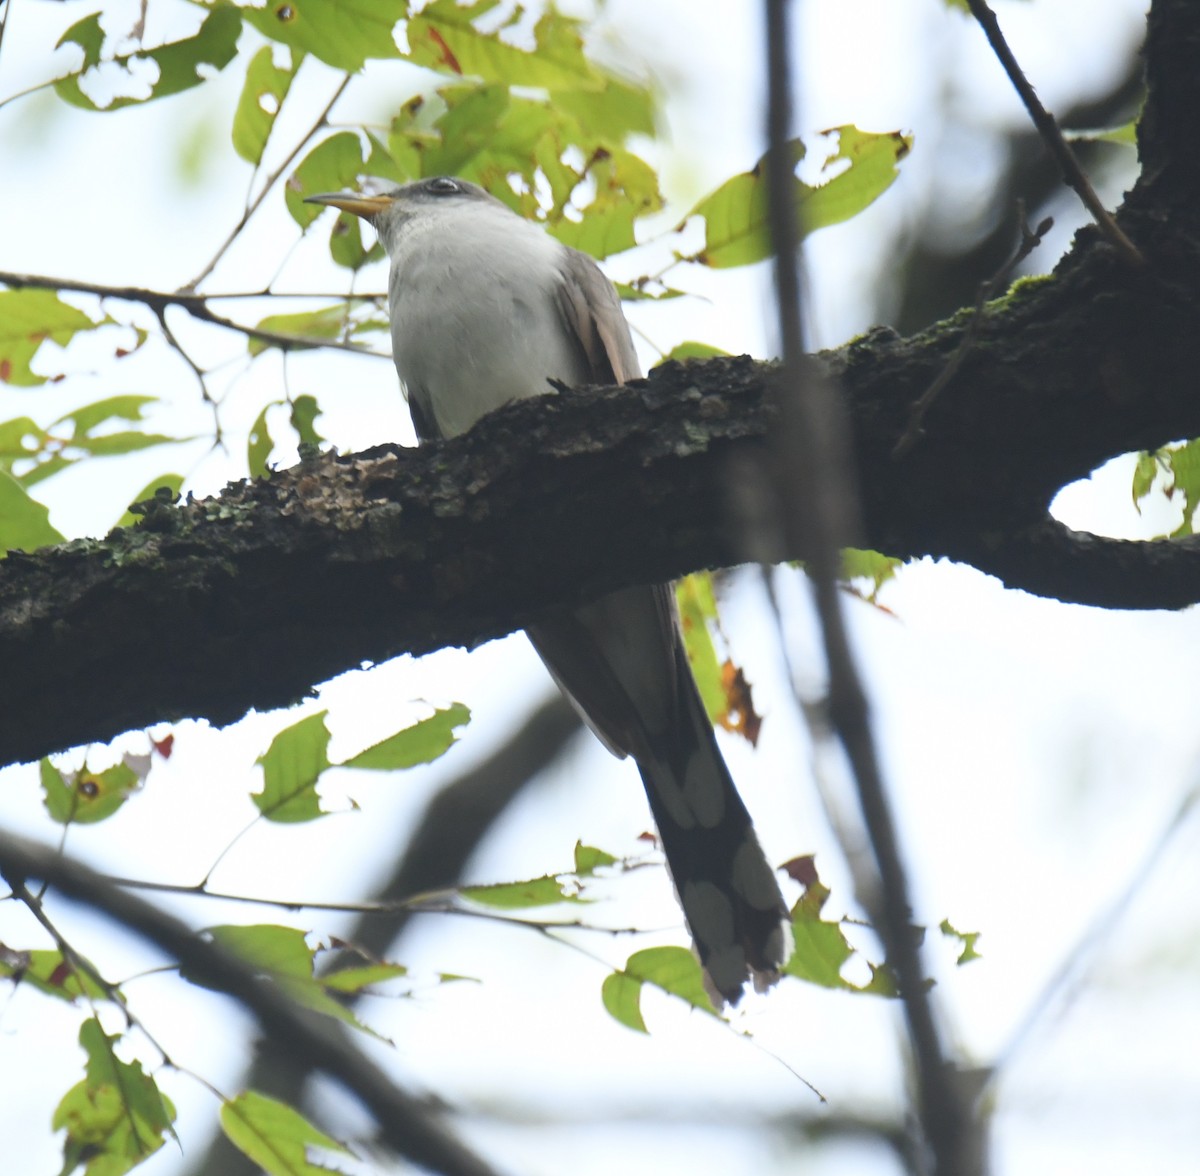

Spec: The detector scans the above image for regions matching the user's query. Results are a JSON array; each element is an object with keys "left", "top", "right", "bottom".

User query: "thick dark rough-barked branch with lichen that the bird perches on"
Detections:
[{"left": 0, "top": 0, "right": 1200, "bottom": 762}]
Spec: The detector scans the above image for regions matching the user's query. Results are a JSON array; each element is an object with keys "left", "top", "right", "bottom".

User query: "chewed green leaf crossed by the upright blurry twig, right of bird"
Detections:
[{"left": 679, "top": 126, "right": 912, "bottom": 269}]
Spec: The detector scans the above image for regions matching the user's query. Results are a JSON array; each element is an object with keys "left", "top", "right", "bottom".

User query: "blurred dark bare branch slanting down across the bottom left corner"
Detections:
[{"left": 0, "top": 833, "right": 494, "bottom": 1176}]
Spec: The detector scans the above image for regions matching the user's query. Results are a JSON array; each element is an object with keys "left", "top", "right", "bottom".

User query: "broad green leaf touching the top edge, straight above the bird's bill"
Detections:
[{"left": 242, "top": 0, "right": 408, "bottom": 73}]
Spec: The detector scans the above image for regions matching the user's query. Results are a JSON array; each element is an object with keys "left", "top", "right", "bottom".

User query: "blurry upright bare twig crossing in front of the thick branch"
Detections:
[{"left": 766, "top": 0, "right": 978, "bottom": 1176}]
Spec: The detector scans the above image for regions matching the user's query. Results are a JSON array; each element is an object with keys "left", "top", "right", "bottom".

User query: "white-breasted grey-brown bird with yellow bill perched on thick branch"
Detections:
[{"left": 307, "top": 175, "right": 792, "bottom": 1008}]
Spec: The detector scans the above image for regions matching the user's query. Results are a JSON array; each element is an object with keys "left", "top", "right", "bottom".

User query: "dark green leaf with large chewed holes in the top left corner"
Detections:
[{"left": 54, "top": 5, "right": 241, "bottom": 110}]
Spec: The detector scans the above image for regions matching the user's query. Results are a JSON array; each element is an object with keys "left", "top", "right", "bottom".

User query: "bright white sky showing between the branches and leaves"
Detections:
[{"left": 0, "top": 0, "right": 1200, "bottom": 1176}]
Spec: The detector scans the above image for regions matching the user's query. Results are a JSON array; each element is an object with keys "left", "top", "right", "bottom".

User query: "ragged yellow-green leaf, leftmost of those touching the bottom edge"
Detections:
[{"left": 52, "top": 1018, "right": 175, "bottom": 1176}]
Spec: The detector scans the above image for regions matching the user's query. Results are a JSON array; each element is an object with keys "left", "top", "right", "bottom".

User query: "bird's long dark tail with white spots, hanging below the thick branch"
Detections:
[{"left": 528, "top": 584, "right": 791, "bottom": 1003}]
